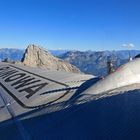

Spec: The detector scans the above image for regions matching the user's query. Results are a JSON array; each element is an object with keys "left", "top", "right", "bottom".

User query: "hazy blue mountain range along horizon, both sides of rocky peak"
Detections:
[{"left": 0, "top": 48, "right": 140, "bottom": 75}]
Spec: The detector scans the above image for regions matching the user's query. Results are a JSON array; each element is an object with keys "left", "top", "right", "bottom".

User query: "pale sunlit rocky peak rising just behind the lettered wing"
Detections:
[{"left": 22, "top": 44, "right": 80, "bottom": 73}]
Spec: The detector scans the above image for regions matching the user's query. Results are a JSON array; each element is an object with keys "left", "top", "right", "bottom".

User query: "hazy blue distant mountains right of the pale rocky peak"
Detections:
[{"left": 60, "top": 50, "right": 140, "bottom": 75}]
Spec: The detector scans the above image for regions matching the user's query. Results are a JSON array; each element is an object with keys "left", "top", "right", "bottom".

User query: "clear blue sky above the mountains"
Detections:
[{"left": 0, "top": 0, "right": 140, "bottom": 50}]
